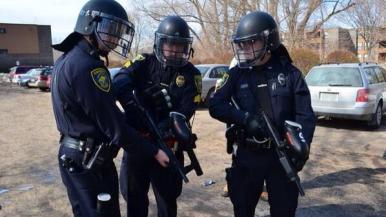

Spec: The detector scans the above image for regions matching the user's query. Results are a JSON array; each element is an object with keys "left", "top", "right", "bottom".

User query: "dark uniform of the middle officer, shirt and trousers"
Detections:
[{"left": 113, "top": 54, "right": 201, "bottom": 217}]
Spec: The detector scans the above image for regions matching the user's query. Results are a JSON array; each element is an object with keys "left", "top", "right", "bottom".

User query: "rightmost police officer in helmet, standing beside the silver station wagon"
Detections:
[{"left": 209, "top": 12, "right": 315, "bottom": 217}]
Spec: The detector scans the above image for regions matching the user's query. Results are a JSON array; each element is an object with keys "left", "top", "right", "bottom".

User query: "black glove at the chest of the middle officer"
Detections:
[{"left": 144, "top": 84, "right": 173, "bottom": 111}]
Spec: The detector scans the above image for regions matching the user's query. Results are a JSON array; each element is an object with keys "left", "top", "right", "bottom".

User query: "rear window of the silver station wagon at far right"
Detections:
[{"left": 306, "top": 67, "right": 363, "bottom": 87}]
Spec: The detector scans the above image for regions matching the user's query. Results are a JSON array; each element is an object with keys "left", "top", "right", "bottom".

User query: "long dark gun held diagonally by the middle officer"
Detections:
[{"left": 133, "top": 90, "right": 189, "bottom": 183}]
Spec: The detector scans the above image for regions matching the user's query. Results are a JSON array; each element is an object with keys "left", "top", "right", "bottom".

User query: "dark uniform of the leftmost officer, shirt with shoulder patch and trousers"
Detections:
[{"left": 52, "top": 39, "right": 154, "bottom": 216}]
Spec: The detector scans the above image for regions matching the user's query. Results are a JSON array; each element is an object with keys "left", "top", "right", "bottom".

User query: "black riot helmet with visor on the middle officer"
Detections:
[{"left": 154, "top": 16, "right": 193, "bottom": 67}]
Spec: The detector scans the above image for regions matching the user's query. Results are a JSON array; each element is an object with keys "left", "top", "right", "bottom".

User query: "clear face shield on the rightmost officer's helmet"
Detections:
[{"left": 232, "top": 31, "right": 267, "bottom": 68}]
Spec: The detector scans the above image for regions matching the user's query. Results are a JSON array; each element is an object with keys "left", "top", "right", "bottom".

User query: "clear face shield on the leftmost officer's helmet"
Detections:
[{"left": 95, "top": 13, "right": 134, "bottom": 57}]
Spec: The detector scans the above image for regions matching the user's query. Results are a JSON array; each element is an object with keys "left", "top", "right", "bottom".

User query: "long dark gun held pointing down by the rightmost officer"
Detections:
[{"left": 231, "top": 97, "right": 305, "bottom": 197}]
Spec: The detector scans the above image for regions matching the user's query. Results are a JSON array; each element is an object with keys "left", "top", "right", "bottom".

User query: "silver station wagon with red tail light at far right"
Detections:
[{"left": 306, "top": 63, "right": 386, "bottom": 128}]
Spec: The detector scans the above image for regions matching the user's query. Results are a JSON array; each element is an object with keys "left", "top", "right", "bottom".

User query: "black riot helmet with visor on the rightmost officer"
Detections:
[{"left": 232, "top": 11, "right": 280, "bottom": 68}]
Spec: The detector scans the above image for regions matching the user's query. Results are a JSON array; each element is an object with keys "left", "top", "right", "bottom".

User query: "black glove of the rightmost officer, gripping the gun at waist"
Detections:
[{"left": 244, "top": 113, "right": 269, "bottom": 139}]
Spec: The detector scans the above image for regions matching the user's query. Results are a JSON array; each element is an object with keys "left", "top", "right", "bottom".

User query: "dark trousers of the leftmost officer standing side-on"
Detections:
[{"left": 58, "top": 146, "right": 121, "bottom": 217}]
